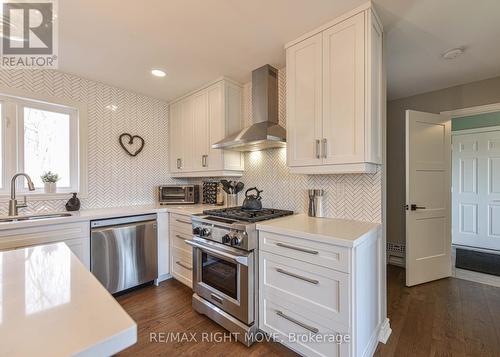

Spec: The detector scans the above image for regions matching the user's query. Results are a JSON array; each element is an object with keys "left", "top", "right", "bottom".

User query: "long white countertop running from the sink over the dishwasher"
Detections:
[{"left": 0, "top": 204, "right": 215, "bottom": 231}]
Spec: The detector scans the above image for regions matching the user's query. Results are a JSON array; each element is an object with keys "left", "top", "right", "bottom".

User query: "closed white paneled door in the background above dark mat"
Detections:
[{"left": 452, "top": 131, "right": 500, "bottom": 250}]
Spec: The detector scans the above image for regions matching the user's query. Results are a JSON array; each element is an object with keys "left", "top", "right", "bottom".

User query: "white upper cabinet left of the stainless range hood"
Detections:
[{"left": 170, "top": 79, "right": 244, "bottom": 177}]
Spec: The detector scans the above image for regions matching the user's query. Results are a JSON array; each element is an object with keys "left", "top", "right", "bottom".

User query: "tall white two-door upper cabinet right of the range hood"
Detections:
[{"left": 286, "top": 5, "right": 384, "bottom": 174}]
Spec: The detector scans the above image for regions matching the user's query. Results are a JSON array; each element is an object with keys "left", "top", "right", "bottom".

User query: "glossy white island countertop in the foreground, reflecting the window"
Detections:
[{"left": 0, "top": 243, "right": 137, "bottom": 356}]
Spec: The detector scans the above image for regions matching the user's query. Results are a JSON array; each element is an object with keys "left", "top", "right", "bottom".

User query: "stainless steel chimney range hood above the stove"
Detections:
[{"left": 212, "top": 64, "right": 286, "bottom": 151}]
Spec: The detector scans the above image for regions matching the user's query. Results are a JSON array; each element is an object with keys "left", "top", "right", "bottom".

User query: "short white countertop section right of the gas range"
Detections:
[{"left": 257, "top": 214, "right": 380, "bottom": 247}]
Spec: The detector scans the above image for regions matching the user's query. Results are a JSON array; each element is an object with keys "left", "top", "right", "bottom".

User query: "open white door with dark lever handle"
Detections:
[{"left": 406, "top": 110, "right": 451, "bottom": 286}]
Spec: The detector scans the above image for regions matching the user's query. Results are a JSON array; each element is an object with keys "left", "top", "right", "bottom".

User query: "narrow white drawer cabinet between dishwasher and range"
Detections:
[{"left": 169, "top": 213, "right": 193, "bottom": 288}]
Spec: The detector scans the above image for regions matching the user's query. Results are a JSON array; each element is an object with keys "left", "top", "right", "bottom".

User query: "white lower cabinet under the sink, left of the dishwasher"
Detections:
[{"left": 0, "top": 221, "right": 90, "bottom": 270}]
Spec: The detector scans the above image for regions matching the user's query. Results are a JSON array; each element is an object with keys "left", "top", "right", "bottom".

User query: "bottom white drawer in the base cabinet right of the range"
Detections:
[{"left": 259, "top": 299, "right": 349, "bottom": 357}]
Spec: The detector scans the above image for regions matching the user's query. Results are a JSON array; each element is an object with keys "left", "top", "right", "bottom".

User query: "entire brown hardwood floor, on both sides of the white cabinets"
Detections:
[{"left": 118, "top": 266, "right": 500, "bottom": 357}]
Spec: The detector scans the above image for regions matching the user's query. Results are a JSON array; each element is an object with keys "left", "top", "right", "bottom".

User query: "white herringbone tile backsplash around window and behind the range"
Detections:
[{"left": 0, "top": 70, "right": 381, "bottom": 222}]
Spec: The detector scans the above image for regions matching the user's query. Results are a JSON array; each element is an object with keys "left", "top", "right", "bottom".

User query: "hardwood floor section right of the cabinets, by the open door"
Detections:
[{"left": 375, "top": 266, "right": 500, "bottom": 357}]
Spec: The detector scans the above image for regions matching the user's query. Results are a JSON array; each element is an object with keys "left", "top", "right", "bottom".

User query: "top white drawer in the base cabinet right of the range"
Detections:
[{"left": 259, "top": 231, "right": 349, "bottom": 273}]
